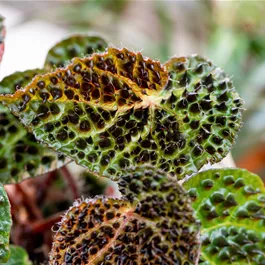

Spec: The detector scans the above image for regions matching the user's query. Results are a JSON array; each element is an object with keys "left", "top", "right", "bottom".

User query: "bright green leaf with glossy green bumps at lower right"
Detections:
[{"left": 184, "top": 168, "right": 265, "bottom": 265}]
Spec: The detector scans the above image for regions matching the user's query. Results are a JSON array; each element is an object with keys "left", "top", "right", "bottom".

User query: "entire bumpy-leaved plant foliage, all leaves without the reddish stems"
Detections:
[{"left": 0, "top": 23, "right": 252, "bottom": 265}]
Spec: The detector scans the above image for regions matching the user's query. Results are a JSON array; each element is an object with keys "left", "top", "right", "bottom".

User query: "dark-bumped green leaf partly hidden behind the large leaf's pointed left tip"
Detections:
[{"left": 0, "top": 69, "right": 65, "bottom": 183}]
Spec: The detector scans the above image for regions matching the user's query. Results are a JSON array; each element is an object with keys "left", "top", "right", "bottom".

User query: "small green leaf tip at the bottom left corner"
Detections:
[{"left": 5, "top": 245, "right": 32, "bottom": 265}]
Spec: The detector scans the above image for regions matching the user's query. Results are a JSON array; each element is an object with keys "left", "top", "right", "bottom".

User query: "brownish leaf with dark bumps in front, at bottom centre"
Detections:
[{"left": 50, "top": 166, "right": 199, "bottom": 265}]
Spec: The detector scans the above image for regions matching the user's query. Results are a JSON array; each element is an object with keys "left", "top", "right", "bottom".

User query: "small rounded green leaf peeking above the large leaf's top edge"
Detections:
[{"left": 45, "top": 35, "right": 108, "bottom": 70}]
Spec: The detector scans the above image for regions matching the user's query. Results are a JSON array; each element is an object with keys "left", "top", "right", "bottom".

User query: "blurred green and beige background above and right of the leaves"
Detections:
[{"left": 2, "top": 0, "right": 265, "bottom": 179}]
